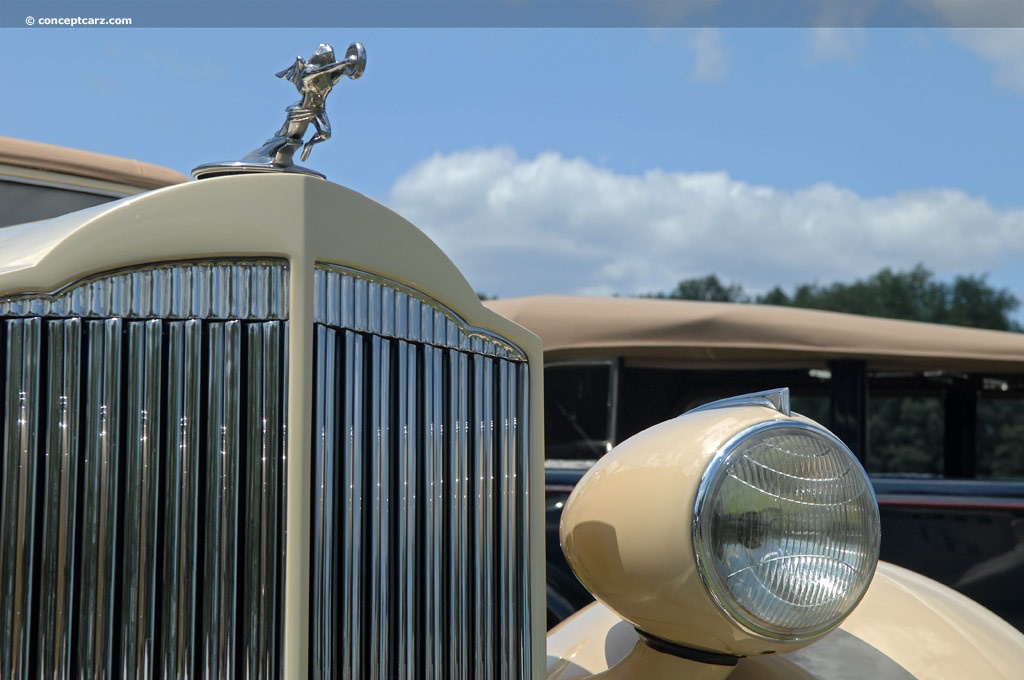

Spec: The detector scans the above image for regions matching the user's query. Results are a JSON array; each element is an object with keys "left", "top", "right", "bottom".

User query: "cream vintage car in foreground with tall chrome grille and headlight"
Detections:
[{"left": 0, "top": 45, "right": 1024, "bottom": 680}]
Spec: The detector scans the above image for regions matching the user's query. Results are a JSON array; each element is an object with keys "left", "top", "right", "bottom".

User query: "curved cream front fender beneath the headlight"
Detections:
[{"left": 547, "top": 562, "right": 1024, "bottom": 680}]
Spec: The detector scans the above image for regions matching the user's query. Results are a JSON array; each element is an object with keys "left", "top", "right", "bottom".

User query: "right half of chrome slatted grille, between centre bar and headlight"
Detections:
[{"left": 310, "top": 265, "right": 532, "bottom": 680}]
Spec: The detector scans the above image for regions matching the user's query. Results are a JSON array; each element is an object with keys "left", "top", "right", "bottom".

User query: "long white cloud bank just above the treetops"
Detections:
[{"left": 389, "top": 148, "right": 1024, "bottom": 297}]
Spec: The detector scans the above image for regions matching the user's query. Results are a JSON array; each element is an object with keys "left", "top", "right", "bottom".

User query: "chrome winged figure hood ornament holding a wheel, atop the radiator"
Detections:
[{"left": 193, "top": 42, "right": 367, "bottom": 179}]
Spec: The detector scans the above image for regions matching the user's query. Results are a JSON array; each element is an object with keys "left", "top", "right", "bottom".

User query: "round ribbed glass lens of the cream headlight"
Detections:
[{"left": 693, "top": 421, "right": 880, "bottom": 640}]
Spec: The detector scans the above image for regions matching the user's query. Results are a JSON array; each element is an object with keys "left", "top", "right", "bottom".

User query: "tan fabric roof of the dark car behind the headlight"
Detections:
[{"left": 486, "top": 295, "right": 1024, "bottom": 373}]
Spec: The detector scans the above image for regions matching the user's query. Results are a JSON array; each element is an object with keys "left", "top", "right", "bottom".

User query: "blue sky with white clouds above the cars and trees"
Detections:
[{"left": 0, "top": 16, "right": 1024, "bottom": 307}]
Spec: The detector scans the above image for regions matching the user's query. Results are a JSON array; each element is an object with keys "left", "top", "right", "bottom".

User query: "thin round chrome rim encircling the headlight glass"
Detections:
[{"left": 691, "top": 418, "right": 881, "bottom": 642}]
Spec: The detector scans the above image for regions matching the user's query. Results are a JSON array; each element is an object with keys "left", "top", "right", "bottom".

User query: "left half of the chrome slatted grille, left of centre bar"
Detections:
[{"left": 0, "top": 261, "right": 288, "bottom": 679}]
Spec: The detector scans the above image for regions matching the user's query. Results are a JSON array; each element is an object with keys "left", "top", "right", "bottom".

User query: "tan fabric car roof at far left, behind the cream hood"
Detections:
[{"left": 0, "top": 137, "right": 188, "bottom": 189}]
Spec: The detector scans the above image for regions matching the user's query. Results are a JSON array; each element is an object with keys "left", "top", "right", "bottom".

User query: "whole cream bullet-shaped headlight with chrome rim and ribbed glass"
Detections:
[{"left": 561, "top": 390, "right": 880, "bottom": 655}]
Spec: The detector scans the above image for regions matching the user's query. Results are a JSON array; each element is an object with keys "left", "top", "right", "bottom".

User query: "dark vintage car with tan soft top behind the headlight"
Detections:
[{"left": 487, "top": 296, "right": 1024, "bottom": 627}]
